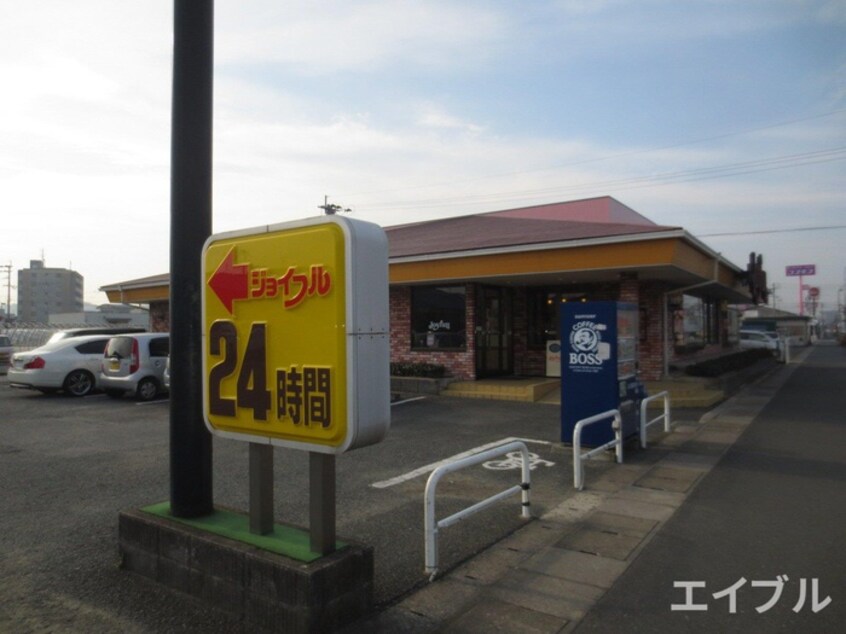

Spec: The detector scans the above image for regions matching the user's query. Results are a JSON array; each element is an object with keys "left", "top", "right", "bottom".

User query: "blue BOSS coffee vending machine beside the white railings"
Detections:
[{"left": 559, "top": 301, "right": 645, "bottom": 447}]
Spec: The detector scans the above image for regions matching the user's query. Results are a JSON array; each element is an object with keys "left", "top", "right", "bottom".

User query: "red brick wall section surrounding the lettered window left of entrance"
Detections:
[{"left": 390, "top": 284, "right": 476, "bottom": 381}]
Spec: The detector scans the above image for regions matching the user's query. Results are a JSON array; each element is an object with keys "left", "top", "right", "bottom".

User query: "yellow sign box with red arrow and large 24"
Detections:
[{"left": 202, "top": 216, "right": 390, "bottom": 454}]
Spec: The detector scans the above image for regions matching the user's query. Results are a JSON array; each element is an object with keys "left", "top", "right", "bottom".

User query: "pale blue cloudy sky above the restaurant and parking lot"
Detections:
[{"left": 0, "top": 0, "right": 846, "bottom": 310}]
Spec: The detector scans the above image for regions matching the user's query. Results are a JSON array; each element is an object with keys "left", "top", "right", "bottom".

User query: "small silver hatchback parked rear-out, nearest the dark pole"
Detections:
[{"left": 100, "top": 332, "right": 170, "bottom": 401}]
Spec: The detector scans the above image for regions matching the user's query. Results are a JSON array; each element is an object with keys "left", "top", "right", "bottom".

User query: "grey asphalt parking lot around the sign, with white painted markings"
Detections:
[{"left": 0, "top": 377, "right": 607, "bottom": 632}]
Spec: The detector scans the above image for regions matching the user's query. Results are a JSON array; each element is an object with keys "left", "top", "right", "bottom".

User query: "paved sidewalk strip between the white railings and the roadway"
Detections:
[{"left": 350, "top": 350, "right": 809, "bottom": 633}]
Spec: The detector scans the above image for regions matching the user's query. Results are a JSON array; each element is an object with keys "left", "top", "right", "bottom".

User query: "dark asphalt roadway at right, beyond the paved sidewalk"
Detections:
[{"left": 575, "top": 345, "right": 846, "bottom": 633}]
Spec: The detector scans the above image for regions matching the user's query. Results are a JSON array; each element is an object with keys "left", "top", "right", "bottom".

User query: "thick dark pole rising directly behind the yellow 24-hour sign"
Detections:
[{"left": 170, "top": 0, "right": 214, "bottom": 518}]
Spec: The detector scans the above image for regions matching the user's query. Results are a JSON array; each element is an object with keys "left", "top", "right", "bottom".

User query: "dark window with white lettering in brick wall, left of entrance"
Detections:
[{"left": 411, "top": 286, "right": 467, "bottom": 350}]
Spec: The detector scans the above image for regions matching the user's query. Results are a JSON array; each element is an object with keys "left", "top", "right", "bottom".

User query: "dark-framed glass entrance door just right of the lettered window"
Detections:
[{"left": 476, "top": 286, "right": 514, "bottom": 378}]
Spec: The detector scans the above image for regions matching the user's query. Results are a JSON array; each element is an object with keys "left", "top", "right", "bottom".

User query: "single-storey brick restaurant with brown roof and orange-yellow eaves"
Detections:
[{"left": 101, "top": 196, "right": 751, "bottom": 380}]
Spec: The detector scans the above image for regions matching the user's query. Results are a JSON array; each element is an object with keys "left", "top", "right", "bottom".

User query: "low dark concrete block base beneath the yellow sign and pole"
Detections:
[{"left": 119, "top": 510, "right": 373, "bottom": 632}]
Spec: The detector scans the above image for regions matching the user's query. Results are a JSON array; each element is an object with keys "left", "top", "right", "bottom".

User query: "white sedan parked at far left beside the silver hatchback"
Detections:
[{"left": 8, "top": 335, "right": 109, "bottom": 396}]
